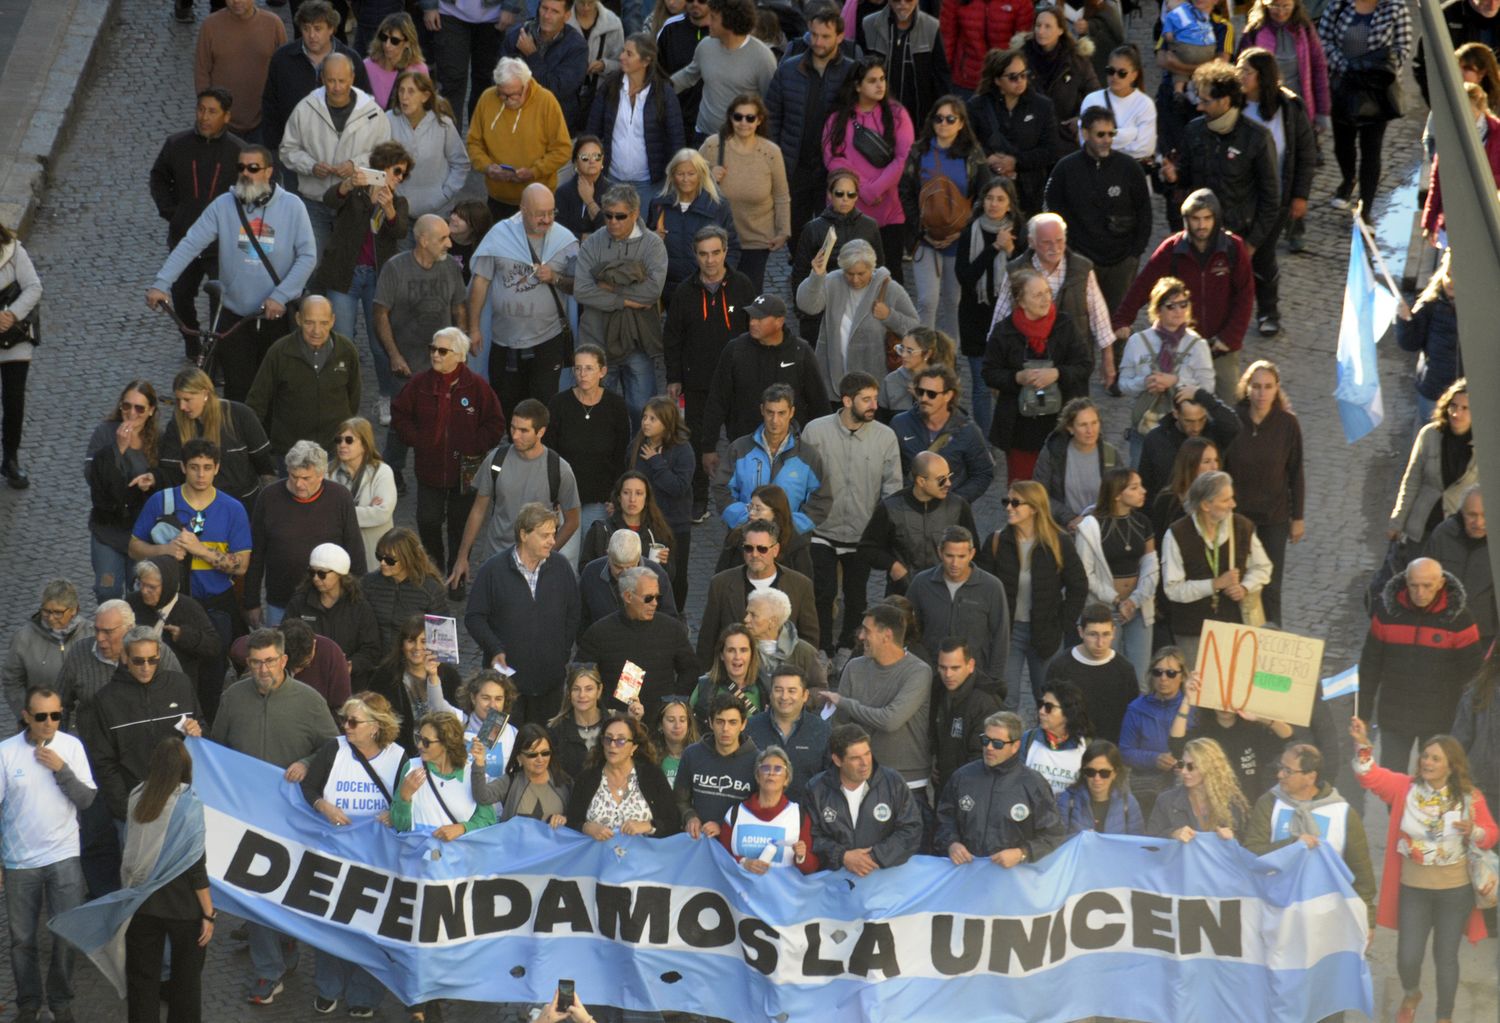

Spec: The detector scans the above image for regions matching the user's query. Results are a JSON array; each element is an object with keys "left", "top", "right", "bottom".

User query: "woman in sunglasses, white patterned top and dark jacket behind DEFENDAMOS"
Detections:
[{"left": 567, "top": 714, "right": 681, "bottom": 842}]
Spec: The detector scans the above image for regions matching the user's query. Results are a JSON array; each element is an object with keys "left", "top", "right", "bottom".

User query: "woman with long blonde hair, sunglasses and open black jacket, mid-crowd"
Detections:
[{"left": 977, "top": 480, "right": 1089, "bottom": 713}]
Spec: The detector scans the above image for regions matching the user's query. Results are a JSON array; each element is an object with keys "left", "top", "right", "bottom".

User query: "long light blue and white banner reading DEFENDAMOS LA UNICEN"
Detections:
[{"left": 191, "top": 740, "right": 1373, "bottom": 1023}]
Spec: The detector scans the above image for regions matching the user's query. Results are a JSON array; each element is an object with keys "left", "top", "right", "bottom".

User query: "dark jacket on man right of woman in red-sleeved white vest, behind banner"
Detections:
[{"left": 804, "top": 764, "right": 923, "bottom": 870}]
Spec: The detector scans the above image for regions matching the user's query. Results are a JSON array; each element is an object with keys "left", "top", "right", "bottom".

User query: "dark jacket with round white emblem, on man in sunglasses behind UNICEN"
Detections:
[{"left": 933, "top": 756, "right": 1068, "bottom": 863}]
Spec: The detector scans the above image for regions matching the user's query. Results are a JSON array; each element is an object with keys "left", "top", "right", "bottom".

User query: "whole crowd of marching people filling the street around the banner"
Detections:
[{"left": 0, "top": 0, "right": 1500, "bottom": 1023}]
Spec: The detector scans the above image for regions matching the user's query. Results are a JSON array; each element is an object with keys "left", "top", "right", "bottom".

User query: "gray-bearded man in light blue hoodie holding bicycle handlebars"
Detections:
[{"left": 146, "top": 146, "right": 317, "bottom": 402}]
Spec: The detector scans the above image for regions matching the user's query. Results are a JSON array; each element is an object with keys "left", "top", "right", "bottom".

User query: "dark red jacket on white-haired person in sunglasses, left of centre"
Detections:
[{"left": 390, "top": 366, "right": 506, "bottom": 488}]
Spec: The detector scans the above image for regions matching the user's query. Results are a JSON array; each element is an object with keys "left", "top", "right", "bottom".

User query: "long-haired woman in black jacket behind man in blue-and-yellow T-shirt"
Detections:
[{"left": 156, "top": 366, "right": 278, "bottom": 515}]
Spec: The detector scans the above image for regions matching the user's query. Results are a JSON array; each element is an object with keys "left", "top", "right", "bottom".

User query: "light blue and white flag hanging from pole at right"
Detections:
[{"left": 1334, "top": 218, "right": 1397, "bottom": 444}]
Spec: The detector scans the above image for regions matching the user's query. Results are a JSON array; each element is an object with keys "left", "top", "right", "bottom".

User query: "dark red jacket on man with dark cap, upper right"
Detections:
[{"left": 1113, "top": 231, "right": 1256, "bottom": 351}]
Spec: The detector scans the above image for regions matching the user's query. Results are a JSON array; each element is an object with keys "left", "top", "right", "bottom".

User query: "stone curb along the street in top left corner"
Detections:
[{"left": 0, "top": 0, "right": 120, "bottom": 237}]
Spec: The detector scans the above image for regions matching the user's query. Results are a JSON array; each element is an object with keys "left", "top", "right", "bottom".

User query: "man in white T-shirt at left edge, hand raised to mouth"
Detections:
[{"left": 0, "top": 687, "right": 96, "bottom": 1023}]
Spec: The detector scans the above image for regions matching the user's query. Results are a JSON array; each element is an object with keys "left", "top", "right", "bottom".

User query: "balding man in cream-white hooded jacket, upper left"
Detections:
[{"left": 281, "top": 53, "right": 390, "bottom": 258}]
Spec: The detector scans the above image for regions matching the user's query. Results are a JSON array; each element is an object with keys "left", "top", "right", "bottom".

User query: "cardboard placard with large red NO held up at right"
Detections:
[{"left": 1197, "top": 621, "right": 1323, "bottom": 725}]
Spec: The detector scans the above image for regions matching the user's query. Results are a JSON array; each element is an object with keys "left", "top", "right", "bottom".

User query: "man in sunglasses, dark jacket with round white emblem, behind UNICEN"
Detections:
[{"left": 935, "top": 711, "right": 1068, "bottom": 870}]
